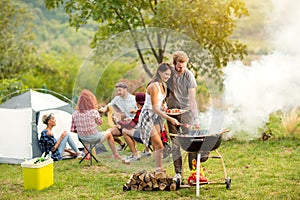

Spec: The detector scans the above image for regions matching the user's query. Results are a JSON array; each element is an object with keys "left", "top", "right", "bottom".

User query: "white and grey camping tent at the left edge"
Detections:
[{"left": 0, "top": 90, "right": 82, "bottom": 164}]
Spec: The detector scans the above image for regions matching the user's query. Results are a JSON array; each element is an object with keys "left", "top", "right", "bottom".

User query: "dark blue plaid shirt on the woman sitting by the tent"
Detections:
[{"left": 39, "top": 130, "right": 62, "bottom": 161}]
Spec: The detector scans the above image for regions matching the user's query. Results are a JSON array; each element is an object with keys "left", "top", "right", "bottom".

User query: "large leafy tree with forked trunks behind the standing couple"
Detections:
[{"left": 45, "top": 0, "right": 248, "bottom": 85}]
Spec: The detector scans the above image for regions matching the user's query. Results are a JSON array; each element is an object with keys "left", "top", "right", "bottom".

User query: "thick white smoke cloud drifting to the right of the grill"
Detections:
[{"left": 223, "top": 0, "right": 300, "bottom": 137}]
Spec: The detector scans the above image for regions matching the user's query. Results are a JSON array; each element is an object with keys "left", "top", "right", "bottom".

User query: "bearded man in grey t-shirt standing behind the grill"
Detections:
[{"left": 166, "top": 51, "right": 198, "bottom": 182}]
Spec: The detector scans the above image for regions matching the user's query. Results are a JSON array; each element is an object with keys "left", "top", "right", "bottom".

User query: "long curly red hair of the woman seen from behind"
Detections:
[{"left": 76, "top": 89, "right": 98, "bottom": 113}]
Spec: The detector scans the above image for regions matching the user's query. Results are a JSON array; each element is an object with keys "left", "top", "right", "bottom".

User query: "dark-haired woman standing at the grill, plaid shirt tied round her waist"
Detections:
[{"left": 139, "top": 63, "right": 180, "bottom": 172}]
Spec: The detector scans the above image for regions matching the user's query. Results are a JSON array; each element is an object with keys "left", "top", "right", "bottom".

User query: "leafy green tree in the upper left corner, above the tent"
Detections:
[{"left": 0, "top": 0, "right": 39, "bottom": 81}]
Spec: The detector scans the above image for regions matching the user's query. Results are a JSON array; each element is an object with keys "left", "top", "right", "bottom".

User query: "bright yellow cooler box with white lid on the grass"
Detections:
[{"left": 21, "top": 158, "right": 54, "bottom": 190}]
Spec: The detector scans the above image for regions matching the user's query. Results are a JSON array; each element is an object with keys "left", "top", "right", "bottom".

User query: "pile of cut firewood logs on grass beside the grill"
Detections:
[{"left": 123, "top": 170, "right": 179, "bottom": 191}]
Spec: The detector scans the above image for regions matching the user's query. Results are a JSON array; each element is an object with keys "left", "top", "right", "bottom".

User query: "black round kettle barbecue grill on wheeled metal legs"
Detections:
[{"left": 170, "top": 130, "right": 231, "bottom": 196}]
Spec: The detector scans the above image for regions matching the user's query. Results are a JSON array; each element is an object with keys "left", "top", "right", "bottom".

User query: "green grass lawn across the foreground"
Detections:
[{"left": 0, "top": 138, "right": 300, "bottom": 199}]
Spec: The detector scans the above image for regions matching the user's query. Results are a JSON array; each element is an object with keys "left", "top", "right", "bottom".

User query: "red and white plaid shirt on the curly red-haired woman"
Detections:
[{"left": 71, "top": 109, "right": 102, "bottom": 136}]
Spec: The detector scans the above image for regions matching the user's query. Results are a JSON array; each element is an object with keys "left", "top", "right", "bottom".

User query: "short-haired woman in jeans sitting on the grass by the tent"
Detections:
[{"left": 39, "top": 113, "right": 81, "bottom": 161}]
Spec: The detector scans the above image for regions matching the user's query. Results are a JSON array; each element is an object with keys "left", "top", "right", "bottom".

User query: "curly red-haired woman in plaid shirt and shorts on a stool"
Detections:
[{"left": 71, "top": 89, "right": 121, "bottom": 160}]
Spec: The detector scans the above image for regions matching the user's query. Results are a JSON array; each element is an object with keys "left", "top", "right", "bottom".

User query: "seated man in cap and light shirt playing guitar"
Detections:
[{"left": 99, "top": 82, "right": 136, "bottom": 151}]
